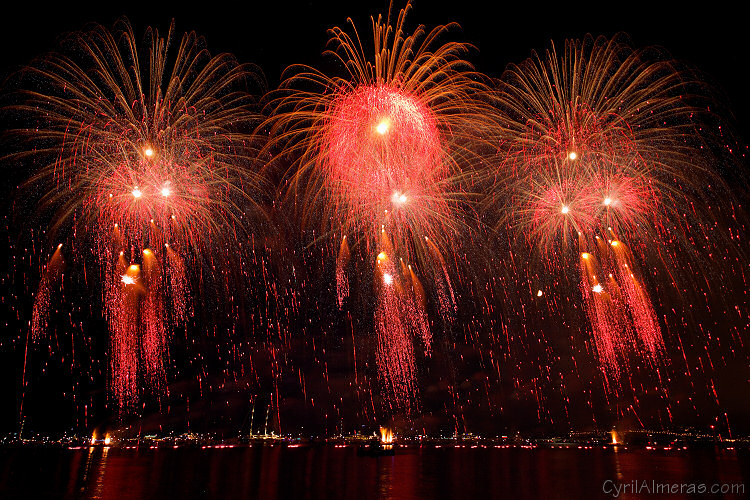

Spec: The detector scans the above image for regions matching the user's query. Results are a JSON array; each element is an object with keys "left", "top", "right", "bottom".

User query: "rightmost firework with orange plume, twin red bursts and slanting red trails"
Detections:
[{"left": 489, "top": 36, "right": 740, "bottom": 392}]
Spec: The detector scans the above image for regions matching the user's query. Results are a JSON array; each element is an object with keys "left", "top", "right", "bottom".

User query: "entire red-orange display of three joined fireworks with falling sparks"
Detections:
[{"left": 3, "top": 3, "right": 748, "bottom": 434}]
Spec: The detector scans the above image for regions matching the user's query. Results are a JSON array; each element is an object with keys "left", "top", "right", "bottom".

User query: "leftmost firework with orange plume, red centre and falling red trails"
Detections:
[{"left": 8, "top": 20, "right": 262, "bottom": 406}]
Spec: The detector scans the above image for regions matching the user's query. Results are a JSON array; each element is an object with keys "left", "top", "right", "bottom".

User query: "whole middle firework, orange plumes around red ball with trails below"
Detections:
[{"left": 266, "top": 3, "right": 496, "bottom": 412}]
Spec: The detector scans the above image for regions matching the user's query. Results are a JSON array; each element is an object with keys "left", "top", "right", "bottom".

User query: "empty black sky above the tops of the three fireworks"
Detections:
[{"left": 0, "top": 0, "right": 750, "bottom": 136}]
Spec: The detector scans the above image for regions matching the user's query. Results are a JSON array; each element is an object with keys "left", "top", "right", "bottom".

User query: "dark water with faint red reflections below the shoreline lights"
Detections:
[{"left": 0, "top": 445, "right": 750, "bottom": 500}]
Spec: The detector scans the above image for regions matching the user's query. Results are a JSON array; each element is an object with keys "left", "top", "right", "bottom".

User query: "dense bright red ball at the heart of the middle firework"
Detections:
[{"left": 323, "top": 86, "right": 448, "bottom": 230}]
